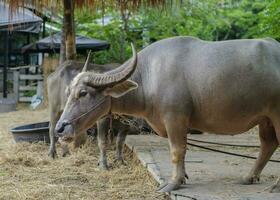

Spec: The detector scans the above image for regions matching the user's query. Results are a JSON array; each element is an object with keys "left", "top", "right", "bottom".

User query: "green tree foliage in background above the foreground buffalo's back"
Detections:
[{"left": 72, "top": 0, "right": 280, "bottom": 63}]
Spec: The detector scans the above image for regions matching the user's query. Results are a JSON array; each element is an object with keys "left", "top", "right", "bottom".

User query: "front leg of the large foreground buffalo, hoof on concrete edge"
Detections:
[{"left": 158, "top": 118, "right": 187, "bottom": 192}]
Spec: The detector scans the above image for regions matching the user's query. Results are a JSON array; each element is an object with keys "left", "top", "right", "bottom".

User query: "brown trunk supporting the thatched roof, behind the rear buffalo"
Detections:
[{"left": 63, "top": 0, "right": 76, "bottom": 60}]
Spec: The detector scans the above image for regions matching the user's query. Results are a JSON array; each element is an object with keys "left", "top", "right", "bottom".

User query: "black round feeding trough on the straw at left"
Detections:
[{"left": 10, "top": 122, "right": 50, "bottom": 143}]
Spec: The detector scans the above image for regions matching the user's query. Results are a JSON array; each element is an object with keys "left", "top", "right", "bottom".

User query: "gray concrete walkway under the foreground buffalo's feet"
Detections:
[{"left": 126, "top": 134, "right": 280, "bottom": 200}]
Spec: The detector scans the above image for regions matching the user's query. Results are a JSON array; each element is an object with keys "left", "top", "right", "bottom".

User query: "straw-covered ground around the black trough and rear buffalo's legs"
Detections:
[{"left": 0, "top": 107, "right": 167, "bottom": 200}]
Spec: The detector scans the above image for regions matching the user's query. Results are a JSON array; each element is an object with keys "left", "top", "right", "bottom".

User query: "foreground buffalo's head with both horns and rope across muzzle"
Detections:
[{"left": 55, "top": 45, "right": 138, "bottom": 141}]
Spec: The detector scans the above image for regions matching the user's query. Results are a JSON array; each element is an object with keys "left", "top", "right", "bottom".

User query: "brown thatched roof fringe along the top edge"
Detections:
[{"left": 3, "top": 0, "right": 172, "bottom": 11}]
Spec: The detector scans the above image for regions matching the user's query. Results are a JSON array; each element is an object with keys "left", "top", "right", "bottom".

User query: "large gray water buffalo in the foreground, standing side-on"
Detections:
[{"left": 56, "top": 37, "right": 280, "bottom": 192}]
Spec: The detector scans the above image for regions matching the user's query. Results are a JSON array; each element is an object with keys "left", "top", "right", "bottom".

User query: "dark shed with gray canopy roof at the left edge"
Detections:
[{"left": 0, "top": 2, "right": 43, "bottom": 98}]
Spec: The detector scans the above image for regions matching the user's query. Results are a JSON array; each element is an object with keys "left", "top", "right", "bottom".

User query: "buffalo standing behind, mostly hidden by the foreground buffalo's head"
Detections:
[{"left": 47, "top": 61, "right": 123, "bottom": 159}]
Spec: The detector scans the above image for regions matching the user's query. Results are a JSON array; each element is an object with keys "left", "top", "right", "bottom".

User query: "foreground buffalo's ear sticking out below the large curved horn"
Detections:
[{"left": 103, "top": 80, "right": 138, "bottom": 98}]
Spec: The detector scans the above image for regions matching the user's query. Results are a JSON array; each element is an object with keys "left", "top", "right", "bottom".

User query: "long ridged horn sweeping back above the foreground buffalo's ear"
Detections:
[{"left": 87, "top": 43, "right": 137, "bottom": 87}]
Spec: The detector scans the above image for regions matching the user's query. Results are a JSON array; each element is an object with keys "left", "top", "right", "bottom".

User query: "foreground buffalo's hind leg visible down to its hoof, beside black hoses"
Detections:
[{"left": 241, "top": 120, "right": 278, "bottom": 185}]
